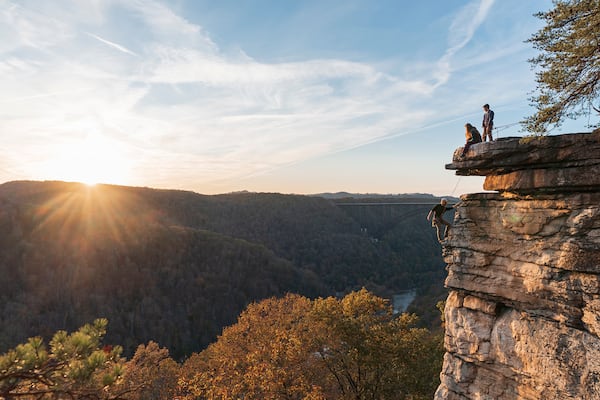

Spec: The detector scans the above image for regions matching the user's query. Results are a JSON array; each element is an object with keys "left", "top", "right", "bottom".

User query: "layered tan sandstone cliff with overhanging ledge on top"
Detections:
[{"left": 436, "top": 133, "right": 600, "bottom": 400}]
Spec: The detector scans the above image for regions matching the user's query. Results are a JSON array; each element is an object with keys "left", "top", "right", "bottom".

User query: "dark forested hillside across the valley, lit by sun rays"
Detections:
[{"left": 0, "top": 182, "right": 444, "bottom": 357}]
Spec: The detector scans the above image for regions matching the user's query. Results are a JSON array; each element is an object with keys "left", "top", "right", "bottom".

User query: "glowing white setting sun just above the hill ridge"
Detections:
[{"left": 43, "top": 135, "right": 131, "bottom": 186}]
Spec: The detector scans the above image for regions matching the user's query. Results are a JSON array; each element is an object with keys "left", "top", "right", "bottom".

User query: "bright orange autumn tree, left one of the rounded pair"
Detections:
[{"left": 180, "top": 294, "right": 324, "bottom": 400}]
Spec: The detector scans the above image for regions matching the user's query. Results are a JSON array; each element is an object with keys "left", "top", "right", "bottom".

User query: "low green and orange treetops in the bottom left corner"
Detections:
[{"left": 0, "top": 318, "right": 180, "bottom": 400}]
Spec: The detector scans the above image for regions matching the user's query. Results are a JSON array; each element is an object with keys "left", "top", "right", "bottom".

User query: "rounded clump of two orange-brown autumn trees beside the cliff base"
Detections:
[{"left": 180, "top": 289, "right": 443, "bottom": 400}]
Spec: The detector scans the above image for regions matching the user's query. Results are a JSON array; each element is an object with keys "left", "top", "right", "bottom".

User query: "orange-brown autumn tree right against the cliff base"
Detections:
[{"left": 313, "top": 289, "right": 443, "bottom": 400}]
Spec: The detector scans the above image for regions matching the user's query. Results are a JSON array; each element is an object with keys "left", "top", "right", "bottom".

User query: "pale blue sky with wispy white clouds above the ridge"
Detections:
[{"left": 0, "top": 0, "right": 588, "bottom": 196}]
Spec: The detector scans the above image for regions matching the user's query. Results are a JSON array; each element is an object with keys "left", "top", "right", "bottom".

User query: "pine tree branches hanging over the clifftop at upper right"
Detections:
[{"left": 523, "top": 0, "right": 600, "bottom": 134}]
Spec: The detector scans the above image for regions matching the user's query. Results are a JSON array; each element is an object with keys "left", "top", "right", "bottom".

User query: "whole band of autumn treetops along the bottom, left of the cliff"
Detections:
[{"left": 0, "top": 289, "right": 442, "bottom": 400}]
